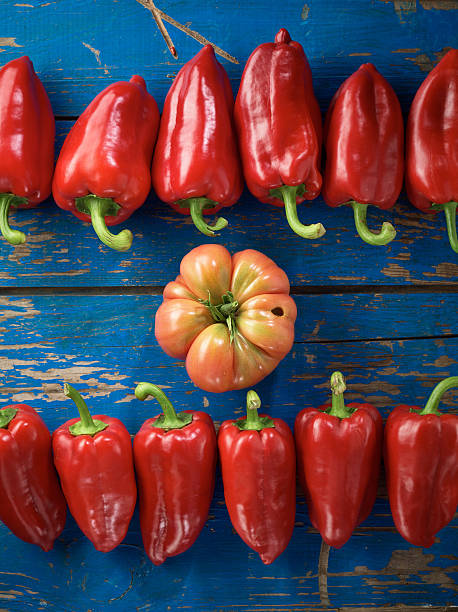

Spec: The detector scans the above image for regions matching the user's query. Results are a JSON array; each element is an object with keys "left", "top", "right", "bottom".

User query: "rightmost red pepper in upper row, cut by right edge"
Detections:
[{"left": 406, "top": 49, "right": 458, "bottom": 253}]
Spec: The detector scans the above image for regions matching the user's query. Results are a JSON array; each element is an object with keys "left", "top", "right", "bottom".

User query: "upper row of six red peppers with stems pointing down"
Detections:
[{"left": 0, "top": 34, "right": 458, "bottom": 252}]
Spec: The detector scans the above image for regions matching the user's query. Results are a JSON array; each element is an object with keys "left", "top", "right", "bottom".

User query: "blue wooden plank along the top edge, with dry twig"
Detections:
[{"left": 0, "top": 0, "right": 457, "bottom": 115}]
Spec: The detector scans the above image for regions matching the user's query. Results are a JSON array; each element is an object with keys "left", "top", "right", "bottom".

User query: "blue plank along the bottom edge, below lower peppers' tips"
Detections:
[{"left": 0, "top": 498, "right": 457, "bottom": 612}]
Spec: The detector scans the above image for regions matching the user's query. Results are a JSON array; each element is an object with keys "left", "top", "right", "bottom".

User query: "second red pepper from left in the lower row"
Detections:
[{"left": 53, "top": 384, "right": 137, "bottom": 552}]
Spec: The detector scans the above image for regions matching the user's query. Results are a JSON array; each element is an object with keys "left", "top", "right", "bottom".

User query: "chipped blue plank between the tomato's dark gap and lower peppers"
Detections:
[{"left": 0, "top": 294, "right": 458, "bottom": 432}]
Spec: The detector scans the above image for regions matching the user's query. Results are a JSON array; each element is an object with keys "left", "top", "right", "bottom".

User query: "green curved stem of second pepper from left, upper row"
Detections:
[{"left": 75, "top": 194, "right": 133, "bottom": 251}]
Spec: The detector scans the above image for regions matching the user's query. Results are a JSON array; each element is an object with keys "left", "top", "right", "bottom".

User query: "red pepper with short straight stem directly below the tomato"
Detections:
[{"left": 218, "top": 391, "right": 296, "bottom": 564}]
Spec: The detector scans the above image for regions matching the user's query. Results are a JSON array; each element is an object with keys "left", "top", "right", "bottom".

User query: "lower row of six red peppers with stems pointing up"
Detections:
[{"left": 0, "top": 372, "right": 458, "bottom": 565}]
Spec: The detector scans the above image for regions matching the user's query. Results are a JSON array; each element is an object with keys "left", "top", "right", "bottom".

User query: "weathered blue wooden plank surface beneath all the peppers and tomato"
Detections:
[{"left": 0, "top": 0, "right": 458, "bottom": 612}]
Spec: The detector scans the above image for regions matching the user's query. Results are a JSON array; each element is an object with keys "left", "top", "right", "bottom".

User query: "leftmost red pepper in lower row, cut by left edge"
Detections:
[{"left": 0, "top": 404, "right": 67, "bottom": 551}]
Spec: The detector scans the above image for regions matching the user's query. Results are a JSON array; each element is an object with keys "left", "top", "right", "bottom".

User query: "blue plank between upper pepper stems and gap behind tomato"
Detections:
[{"left": 0, "top": 165, "right": 458, "bottom": 287}]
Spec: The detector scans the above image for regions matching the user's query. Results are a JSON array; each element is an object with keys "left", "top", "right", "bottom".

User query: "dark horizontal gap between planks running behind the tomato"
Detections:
[{"left": 0, "top": 283, "right": 458, "bottom": 297}]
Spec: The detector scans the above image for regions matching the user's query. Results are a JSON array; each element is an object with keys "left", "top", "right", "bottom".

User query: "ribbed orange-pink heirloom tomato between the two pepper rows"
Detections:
[{"left": 155, "top": 244, "right": 297, "bottom": 393}]
